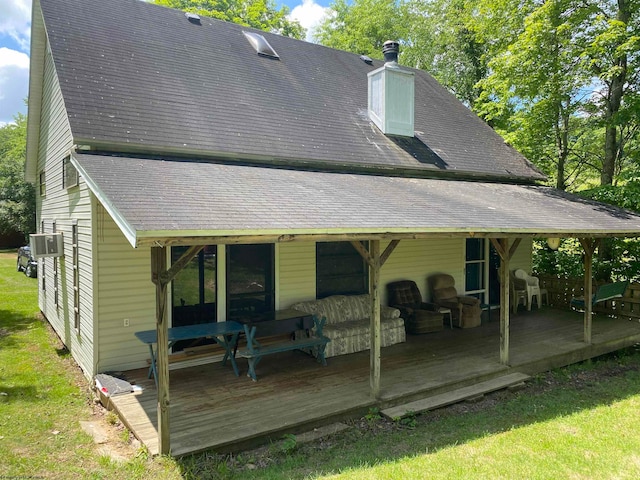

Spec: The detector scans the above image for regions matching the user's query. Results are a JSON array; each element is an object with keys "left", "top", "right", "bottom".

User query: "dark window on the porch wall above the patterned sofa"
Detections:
[{"left": 316, "top": 242, "right": 369, "bottom": 298}]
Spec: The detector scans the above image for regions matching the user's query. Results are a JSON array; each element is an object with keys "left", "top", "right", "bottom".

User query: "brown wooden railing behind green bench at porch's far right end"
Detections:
[{"left": 537, "top": 275, "right": 640, "bottom": 319}]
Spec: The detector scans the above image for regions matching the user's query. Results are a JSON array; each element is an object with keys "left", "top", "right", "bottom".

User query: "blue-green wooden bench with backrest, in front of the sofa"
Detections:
[{"left": 240, "top": 316, "right": 330, "bottom": 382}]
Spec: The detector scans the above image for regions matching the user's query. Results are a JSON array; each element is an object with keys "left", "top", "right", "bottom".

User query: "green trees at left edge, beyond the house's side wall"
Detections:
[{"left": 0, "top": 114, "right": 36, "bottom": 240}]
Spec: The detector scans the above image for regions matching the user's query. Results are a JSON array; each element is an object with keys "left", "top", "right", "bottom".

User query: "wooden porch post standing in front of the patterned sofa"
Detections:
[{"left": 369, "top": 240, "right": 381, "bottom": 398}]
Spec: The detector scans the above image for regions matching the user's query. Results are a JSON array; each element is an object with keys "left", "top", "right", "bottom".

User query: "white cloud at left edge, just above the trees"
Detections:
[{"left": 0, "top": 47, "right": 29, "bottom": 124}]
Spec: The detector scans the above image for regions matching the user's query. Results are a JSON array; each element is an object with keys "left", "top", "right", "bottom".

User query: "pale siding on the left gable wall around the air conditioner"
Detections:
[{"left": 36, "top": 42, "right": 95, "bottom": 377}]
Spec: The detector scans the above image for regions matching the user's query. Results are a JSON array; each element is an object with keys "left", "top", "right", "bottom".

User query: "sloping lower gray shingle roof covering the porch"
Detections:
[{"left": 72, "top": 153, "right": 640, "bottom": 247}]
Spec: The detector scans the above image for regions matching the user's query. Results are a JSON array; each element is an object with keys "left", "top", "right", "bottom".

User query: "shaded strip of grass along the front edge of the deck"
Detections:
[{"left": 177, "top": 349, "right": 640, "bottom": 479}]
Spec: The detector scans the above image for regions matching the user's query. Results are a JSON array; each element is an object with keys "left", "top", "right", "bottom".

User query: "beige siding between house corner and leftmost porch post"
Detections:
[{"left": 95, "top": 204, "right": 156, "bottom": 372}]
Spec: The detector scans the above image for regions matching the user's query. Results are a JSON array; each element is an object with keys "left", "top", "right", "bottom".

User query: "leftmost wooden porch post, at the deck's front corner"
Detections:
[{"left": 151, "top": 247, "right": 171, "bottom": 455}]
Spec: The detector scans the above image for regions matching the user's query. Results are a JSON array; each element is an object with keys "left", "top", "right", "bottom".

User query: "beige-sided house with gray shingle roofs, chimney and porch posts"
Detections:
[{"left": 26, "top": 0, "right": 640, "bottom": 450}]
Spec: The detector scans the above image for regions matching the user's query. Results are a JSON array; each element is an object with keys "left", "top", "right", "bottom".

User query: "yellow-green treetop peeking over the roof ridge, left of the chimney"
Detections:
[{"left": 153, "top": 0, "right": 305, "bottom": 39}]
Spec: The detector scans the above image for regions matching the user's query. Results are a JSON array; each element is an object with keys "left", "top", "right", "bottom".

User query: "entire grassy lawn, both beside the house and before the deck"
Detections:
[{"left": 0, "top": 252, "right": 640, "bottom": 479}]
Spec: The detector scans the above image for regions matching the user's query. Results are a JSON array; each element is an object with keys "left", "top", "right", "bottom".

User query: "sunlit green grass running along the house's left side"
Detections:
[{"left": 0, "top": 252, "right": 181, "bottom": 479}]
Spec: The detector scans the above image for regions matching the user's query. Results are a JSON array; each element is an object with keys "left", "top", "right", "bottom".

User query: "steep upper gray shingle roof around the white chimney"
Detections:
[{"left": 41, "top": 0, "right": 543, "bottom": 181}]
